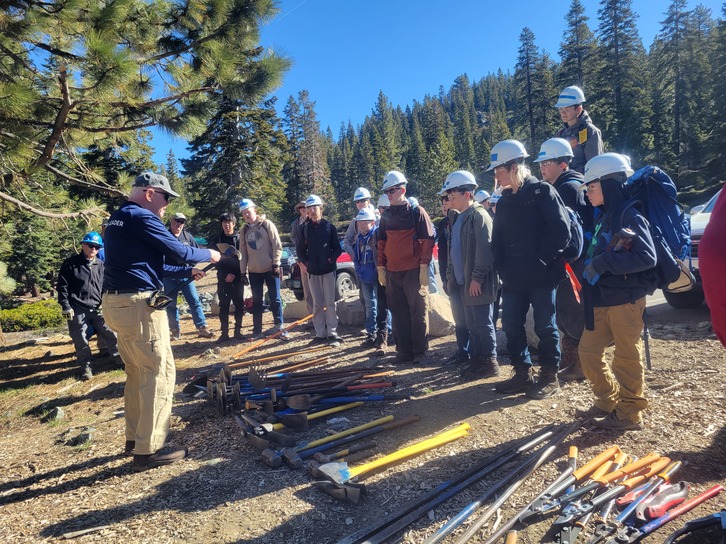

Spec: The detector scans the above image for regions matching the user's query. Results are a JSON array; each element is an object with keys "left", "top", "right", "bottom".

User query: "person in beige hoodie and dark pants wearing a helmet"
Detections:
[{"left": 239, "top": 198, "right": 290, "bottom": 340}]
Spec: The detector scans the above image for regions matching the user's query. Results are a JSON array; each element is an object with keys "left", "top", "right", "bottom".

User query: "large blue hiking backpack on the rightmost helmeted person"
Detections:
[{"left": 621, "top": 166, "right": 696, "bottom": 293}]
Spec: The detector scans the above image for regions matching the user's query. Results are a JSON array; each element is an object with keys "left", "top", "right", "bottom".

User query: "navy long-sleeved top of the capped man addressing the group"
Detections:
[{"left": 103, "top": 202, "right": 210, "bottom": 292}]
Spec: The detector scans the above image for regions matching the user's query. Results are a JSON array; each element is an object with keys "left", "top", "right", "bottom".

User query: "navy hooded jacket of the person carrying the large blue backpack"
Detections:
[{"left": 583, "top": 178, "right": 657, "bottom": 318}]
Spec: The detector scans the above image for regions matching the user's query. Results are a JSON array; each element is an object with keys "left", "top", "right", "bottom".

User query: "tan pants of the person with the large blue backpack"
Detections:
[{"left": 579, "top": 297, "right": 648, "bottom": 423}]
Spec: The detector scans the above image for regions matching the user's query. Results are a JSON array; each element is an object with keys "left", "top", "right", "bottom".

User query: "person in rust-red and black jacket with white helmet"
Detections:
[{"left": 378, "top": 170, "right": 434, "bottom": 364}]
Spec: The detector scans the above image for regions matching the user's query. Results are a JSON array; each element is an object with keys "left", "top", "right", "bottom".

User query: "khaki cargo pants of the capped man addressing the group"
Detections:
[{"left": 103, "top": 293, "right": 176, "bottom": 455}]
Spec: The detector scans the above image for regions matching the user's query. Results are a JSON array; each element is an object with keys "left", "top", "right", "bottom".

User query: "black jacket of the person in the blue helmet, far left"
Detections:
[{"left": 56, "top": 253, "right": 103, "bottom": 310}]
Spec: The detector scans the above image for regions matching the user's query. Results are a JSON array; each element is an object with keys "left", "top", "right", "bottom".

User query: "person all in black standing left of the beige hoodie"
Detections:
[{"left": 211, "top": 213, "right": 248, "bottom": 343}]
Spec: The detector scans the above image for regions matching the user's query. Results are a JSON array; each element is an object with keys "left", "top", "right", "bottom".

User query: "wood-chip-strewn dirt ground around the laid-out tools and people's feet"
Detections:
[{"left": 0, "top": 280, "right": 726, "bottom": 544}]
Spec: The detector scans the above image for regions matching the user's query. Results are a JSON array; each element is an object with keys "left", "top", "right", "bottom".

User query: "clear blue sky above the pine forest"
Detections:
[{"left": 152, "top": 0, "right": 721, "bottom": 164}]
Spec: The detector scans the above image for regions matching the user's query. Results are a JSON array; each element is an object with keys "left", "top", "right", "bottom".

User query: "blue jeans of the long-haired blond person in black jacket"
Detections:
[{"left": 502, "top": 287, "right": 560, "bottom": 368}]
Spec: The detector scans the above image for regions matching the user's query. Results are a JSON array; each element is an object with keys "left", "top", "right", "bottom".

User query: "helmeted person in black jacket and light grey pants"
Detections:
[{"left": 297, "top": 195, "right": 343, "bottom": 346}]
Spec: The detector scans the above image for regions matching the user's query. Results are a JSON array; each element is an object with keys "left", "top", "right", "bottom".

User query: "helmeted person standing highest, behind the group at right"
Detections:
[{"left": 555, "top": 85, "right": 604, "bottom": 174}]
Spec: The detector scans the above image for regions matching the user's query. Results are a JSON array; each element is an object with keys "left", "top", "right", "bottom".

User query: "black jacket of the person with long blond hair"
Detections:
[{"left": 492, "top": 176, "right": 570, "bottom": 291}]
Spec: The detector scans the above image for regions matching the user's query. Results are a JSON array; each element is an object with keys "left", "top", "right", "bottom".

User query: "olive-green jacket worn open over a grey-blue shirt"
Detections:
[{"left": 446, "top": 202, "right": 499, "bottom": 306}]
